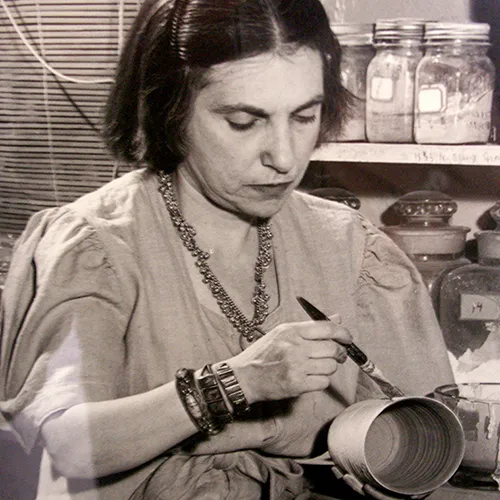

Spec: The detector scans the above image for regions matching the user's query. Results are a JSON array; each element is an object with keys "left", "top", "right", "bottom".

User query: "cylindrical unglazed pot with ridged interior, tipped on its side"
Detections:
[{"left": 328, "top": 397, "right": 465, "bottom": 498}]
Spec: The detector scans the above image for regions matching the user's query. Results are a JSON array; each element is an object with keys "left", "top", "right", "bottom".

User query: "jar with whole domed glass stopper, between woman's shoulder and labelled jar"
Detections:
[{"left": 381, "top": 191, "right": 470, "bottom": 315}]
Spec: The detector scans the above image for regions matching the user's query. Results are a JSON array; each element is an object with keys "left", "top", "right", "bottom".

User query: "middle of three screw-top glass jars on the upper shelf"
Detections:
[{"left": 366, "top": 19, "right": 425, "bottom": 143}]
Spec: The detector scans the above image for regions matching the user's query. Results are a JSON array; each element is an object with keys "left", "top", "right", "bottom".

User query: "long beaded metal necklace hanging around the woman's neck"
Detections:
[{"left": 158, "top": 172, "right": 273, "bottom": 342}]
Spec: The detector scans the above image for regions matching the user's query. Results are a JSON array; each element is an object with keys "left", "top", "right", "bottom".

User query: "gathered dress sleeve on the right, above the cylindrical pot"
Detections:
[{"left": 357, "top": 217, "right": 453, "bottom": 396}]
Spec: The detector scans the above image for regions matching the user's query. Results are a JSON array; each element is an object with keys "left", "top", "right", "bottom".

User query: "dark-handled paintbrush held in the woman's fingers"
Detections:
[{"left": 297, "top": 297, "right": 405, "bottom": 398}]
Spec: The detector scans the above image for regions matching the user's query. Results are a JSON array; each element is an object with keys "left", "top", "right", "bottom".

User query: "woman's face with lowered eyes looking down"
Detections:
[{"left": 179, "top": 48, "right": 323, "bottom": 217}]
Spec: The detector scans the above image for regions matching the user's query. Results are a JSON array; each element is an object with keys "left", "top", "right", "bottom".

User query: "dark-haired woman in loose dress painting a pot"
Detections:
[{"left": 1, "top": 0, "right": 451, "bottom": 500}]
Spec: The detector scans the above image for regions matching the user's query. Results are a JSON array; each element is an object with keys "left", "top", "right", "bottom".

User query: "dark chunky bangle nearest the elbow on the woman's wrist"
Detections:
[{"left": 175, "top": 368, "right": 222, "bottom": 435}]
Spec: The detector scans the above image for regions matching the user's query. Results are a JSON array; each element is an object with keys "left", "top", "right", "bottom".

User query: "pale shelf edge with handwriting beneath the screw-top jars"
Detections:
[{"left": 312, "top": 142, "right": 500, "bottom": 166}]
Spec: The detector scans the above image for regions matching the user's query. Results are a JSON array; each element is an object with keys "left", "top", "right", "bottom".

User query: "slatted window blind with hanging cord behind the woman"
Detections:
[{"left": 0, "top": 0, "right": 141, "bottom": 235}]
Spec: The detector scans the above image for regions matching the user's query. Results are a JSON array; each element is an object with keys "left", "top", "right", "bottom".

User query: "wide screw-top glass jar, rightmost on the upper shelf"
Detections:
[{"left": 414, "top": 23, "right": 495, "bottom": 144}]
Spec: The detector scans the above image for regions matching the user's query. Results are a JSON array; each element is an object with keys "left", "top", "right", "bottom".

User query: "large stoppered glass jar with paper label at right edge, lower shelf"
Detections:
[{"left": 440, "top": 202, "right": 500, "bottom": 382}]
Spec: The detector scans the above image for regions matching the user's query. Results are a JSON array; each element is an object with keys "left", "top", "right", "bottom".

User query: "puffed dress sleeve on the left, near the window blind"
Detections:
[{"left": 0, "top": 209, "right": 131, "bottom": 450}]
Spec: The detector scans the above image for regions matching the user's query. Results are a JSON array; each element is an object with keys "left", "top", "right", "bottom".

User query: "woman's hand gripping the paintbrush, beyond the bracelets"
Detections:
[{"left": 227, "top": 321, "right": 352, "bottom": 404}]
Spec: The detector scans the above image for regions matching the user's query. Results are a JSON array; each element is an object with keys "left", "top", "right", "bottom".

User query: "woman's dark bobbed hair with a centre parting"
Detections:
[{"left": 103, "top": 0, "right": 349, "bottom": 171}]
